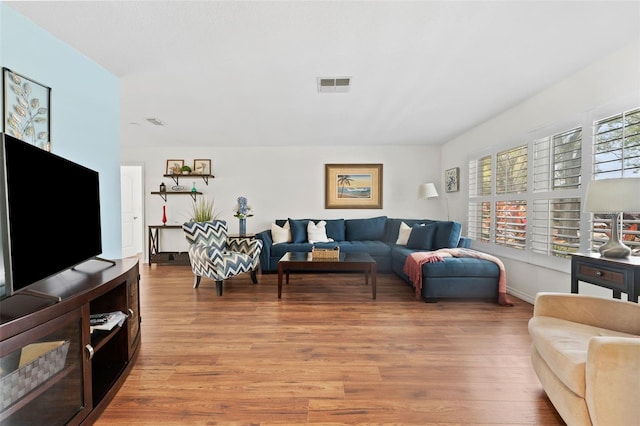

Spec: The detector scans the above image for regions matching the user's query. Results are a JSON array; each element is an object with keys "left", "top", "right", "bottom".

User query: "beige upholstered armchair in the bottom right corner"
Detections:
[{"left": 529, "top": 293, "right": 640, "bottom": 426}]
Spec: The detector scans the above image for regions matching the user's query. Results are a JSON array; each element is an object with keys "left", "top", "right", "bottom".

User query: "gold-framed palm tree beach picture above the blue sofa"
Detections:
[{"left": 325, "top": 164, "right": 382, "bottom": 209}]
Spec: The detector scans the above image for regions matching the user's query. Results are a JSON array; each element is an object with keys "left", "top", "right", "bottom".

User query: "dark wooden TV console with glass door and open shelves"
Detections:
[{"left": 0, "top": 258, "right": 141, "bottom": 425}]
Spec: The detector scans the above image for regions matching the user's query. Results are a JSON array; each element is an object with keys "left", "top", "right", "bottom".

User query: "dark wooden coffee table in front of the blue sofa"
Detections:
[{"left": 278, "top": 252, "right": 376, "bottom": 299}]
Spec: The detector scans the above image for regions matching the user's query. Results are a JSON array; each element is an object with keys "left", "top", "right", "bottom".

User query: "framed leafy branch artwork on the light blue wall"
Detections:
[{"left": 2, "top": 68, "right": 51, "bottom": 151}]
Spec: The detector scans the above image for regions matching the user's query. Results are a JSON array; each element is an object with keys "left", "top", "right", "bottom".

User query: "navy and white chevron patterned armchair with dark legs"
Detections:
[{"left": 182, "top": 220, "right": 262, "bottom": 296}]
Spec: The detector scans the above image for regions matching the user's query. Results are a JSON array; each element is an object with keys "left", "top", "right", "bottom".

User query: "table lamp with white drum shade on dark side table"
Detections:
[{"left": 584, "top": 178, "right": 640, "bottom": 258}]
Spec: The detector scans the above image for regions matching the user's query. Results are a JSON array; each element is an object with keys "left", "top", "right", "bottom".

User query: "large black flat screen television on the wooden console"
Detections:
[{"left": 0, "top": 134, "right": 102, "bottom": 298}]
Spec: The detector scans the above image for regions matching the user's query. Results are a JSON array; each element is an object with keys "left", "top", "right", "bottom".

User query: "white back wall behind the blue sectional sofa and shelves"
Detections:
[{"left": 121, "top": 145, "right": 446, "bottom": 253}]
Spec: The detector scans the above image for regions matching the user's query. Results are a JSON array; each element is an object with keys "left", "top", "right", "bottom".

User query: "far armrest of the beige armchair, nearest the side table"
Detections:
[{"left": 533, "top": 292, "right": 640, "bottom": 336}]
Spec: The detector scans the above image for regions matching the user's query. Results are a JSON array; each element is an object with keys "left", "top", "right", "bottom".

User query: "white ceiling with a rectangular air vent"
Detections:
[{"left": 8, "top": 0, "right": 640, "bottom": 147}]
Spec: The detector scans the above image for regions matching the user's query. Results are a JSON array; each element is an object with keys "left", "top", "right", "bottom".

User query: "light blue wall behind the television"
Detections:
[{"left": 0, "top": 3, "right": 122, "bottom": 259}]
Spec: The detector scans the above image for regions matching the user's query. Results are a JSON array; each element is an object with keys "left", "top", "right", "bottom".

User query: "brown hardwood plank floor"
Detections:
[{"left": 96, "top": 264, "right": 564, "bottom": 426}]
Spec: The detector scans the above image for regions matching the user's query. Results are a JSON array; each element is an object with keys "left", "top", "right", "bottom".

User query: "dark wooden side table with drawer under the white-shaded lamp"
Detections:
[{"left": 571, "top": 253, "right": 640, "bottom": 303}]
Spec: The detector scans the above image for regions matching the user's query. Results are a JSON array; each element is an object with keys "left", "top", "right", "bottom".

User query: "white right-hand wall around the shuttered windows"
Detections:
[{"left": 441, "top": 43, "right": 640, "bottom": 302}]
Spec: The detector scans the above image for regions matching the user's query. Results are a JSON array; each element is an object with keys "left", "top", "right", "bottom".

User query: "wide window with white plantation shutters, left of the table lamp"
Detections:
[{"left": 468, "top": 127, "right": 582, "bottom": 257}]
